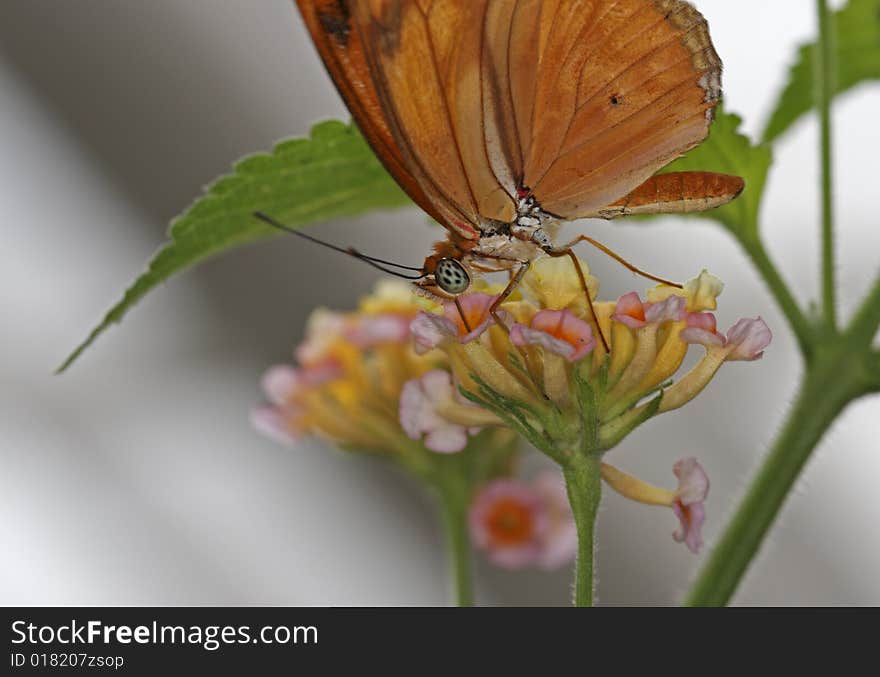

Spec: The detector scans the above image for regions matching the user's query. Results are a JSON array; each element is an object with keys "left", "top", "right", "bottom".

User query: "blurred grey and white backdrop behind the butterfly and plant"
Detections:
[{"left": 0, "top": 0, "right": 880, "bottom": 605}]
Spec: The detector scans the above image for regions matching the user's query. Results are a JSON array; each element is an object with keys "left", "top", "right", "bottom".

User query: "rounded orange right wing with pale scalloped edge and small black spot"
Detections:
[{"left": 498, "top": 0, "right": 721, "bottom": 219}]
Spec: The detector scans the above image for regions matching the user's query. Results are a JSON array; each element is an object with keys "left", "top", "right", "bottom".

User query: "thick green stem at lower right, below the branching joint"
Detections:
[{"left": 685, "top": 352, "right": 864, "bottom": 606}]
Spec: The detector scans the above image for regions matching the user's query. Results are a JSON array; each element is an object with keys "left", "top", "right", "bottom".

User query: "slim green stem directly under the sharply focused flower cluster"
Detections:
[{"left": 563, "top": 454, "right": 602, "bottom": 606}]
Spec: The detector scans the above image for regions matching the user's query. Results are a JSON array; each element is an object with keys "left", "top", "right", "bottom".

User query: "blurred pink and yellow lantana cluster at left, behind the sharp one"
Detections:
[{"left": 252, "top": 281, "right": 510, "bottom": 465}]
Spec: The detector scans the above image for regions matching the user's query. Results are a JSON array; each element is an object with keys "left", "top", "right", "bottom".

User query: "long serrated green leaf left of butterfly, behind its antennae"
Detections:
[{"left": 58, "top": 121, "right": 411, "bottom": 372}]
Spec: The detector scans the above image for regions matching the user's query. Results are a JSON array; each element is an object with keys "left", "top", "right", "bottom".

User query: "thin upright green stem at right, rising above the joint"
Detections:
[{"left": 814, "top": 0, "right": 837, "bottom": 332}]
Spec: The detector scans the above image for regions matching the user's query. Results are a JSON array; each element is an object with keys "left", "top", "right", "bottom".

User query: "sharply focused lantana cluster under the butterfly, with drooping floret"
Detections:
[{"left": 401, "top": 257, "right": 771, "bottom": 552}]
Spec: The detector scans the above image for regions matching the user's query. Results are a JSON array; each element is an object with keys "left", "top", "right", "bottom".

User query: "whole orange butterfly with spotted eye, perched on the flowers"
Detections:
[{"left": 288, "top": 0, "right": 743, "bottom": 346}]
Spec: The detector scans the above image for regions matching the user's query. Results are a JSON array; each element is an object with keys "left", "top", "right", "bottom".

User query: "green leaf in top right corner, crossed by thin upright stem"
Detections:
[{"left": 763, "top": 0, "right": 880, "bottom": 143}]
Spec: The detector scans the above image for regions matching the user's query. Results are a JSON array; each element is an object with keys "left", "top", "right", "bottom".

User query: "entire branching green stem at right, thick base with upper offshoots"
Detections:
[{"left": 686, "top": 0, "right": 868, "bottom": 606}]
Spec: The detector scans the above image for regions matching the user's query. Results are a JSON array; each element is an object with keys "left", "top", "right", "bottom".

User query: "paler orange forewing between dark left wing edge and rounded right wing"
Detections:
[{"left": 349, "top": 0, "right": 515, "bottom": 232}]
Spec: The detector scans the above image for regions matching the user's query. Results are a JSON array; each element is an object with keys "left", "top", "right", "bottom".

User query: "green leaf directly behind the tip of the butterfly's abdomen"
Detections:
[{"left": 663, "top": 108, "right": 773, "bottom": 237}]
